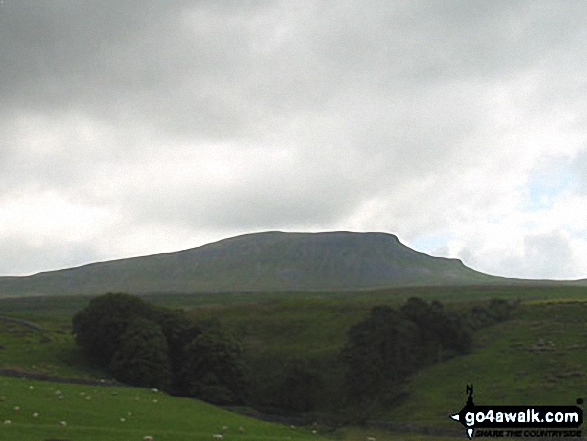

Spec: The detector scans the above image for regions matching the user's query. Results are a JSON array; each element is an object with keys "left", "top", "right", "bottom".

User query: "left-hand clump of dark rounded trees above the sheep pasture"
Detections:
[{"left": 73, "top": 293, "right": 248, "bottom": 404}]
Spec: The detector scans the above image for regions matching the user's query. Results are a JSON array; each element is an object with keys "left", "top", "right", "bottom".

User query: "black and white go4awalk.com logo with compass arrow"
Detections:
[{"left": 450, "top": 385, "right": 583, "bottom": 439}]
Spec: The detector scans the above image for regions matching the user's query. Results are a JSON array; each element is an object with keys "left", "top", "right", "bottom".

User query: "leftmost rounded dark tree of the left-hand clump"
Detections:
[{"left": 73, "top": 293, "right": 153, "bottom": 367}]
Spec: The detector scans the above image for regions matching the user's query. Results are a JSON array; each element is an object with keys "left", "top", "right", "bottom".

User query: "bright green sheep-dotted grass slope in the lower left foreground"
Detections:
[{"left": 0, "top": 377, "right": 326, "bottom": 441}]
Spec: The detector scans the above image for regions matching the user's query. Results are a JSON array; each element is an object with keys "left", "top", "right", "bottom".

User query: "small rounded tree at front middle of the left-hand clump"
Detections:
[{"left": 110, "top": 317, "right": 171, "bottom": 389}]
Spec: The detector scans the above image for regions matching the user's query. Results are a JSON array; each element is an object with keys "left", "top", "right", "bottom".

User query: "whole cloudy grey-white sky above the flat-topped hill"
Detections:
[{"left": 0, "top": 0, "right": 587, "bottom": 279}]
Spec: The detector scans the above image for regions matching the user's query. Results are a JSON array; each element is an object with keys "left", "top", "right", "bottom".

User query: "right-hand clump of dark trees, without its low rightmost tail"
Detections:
[{"left": 342, "top": 297, "right": 471, "bottom": 418}]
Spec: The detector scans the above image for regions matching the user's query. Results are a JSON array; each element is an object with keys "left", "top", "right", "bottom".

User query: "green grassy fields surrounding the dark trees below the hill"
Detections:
[{"left": 0, "top": 286, "right": 587, "bottom": 441}]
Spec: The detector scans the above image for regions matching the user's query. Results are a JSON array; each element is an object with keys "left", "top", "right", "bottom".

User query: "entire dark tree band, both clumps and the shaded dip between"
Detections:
[{"left": 73, "top": 293, "right": 513, "bottom": 418}]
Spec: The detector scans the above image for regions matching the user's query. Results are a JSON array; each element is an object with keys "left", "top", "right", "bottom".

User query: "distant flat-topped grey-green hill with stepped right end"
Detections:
[{"left": 0, "top": 232, "right": 508, "bottom": 296}]
